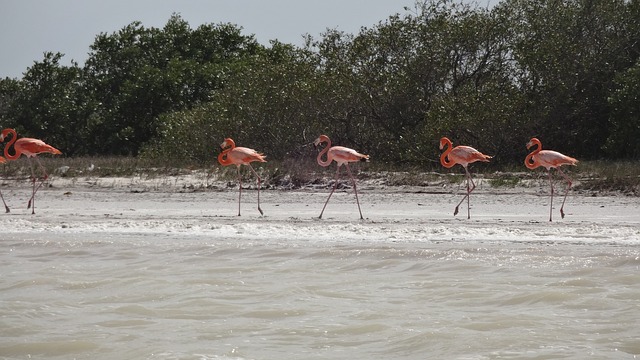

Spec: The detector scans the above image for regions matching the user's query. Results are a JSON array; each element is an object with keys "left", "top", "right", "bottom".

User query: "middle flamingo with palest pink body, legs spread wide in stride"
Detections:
[{"left": 314, "top": 135, "right": 369, "bottom": 220}]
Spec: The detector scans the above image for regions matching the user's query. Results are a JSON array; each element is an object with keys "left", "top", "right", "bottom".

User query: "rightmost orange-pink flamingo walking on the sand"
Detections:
[{"left": 524, "top": 138, "right": 578, "bottom": 221}]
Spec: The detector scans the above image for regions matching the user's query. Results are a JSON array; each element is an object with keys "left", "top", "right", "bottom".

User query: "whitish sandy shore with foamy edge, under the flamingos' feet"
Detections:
[{"left": 0, "top": 173, "right": 640, "bottom": 245}]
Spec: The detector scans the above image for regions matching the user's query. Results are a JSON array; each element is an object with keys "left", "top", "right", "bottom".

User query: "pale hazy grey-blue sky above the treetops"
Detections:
[{"left": 0, "top": 0, "right": 424, "bottom": 78}]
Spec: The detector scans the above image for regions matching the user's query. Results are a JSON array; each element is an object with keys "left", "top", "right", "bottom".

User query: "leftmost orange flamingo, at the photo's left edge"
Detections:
[{"left": 0, "top": 129, "right": 62, "bottom": 214}]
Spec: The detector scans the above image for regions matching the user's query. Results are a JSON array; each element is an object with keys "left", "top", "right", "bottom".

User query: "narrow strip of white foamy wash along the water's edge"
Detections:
[{"left": 2, "top": 218, "right": 640, "bottom": 245}]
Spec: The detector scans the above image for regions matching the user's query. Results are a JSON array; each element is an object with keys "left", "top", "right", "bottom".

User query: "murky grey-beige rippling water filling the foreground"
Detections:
[{"left": 0, "top": 234, "right": 640, "bottom": 359}]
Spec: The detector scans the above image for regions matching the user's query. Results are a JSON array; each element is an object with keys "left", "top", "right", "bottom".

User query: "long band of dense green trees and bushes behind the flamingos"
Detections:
[{"left": 0, "top": 0, "right": 640, "bottom": 168}]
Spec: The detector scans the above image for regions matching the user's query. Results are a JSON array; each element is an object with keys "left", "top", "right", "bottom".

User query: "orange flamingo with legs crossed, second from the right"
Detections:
[{"left": 440, "top": 137, "right": 491, "bottom": 219}]
